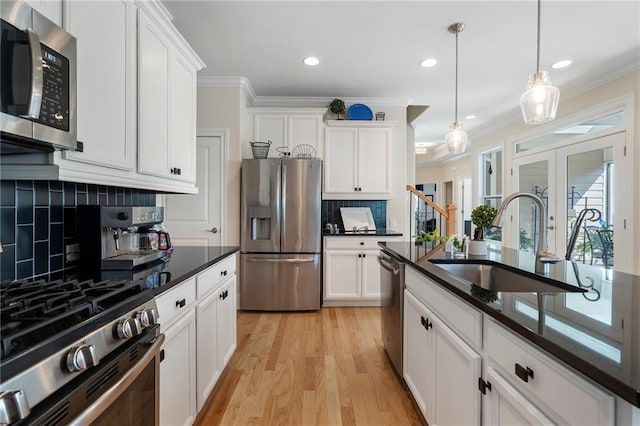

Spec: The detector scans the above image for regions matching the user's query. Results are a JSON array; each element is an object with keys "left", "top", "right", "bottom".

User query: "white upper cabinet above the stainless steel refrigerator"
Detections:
[{"left": 243, "top": 108, "right": 326, "bottom": 158}]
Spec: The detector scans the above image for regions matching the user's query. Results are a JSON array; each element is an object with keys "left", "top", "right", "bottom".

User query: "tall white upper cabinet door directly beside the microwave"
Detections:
[{"left": 63, "top": 0, "right": 136, "bottom": 171}]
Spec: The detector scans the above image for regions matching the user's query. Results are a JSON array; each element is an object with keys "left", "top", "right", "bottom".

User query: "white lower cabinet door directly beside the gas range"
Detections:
[{"left": 160, "top": 309, "right": 196, "bottom": 426}]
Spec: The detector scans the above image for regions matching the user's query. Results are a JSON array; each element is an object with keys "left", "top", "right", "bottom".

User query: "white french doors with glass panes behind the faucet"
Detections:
[{"left": 509, "top": 132, "right": 633, "bottom": 272}]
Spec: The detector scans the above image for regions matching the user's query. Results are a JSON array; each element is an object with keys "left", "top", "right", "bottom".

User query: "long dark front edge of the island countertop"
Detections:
[{"left": 378, "top": 242, "right": 640, "bottom": 408}]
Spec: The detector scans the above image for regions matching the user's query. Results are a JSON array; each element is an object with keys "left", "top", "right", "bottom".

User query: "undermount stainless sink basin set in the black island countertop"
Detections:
[{"left": 430, "top": 260, "right": 585, "bottom": 293}]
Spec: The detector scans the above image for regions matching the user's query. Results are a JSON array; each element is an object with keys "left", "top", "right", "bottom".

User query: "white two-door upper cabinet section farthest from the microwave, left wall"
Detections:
[{"left": 138, "top": 3, "right": 204, "bottom": 190}]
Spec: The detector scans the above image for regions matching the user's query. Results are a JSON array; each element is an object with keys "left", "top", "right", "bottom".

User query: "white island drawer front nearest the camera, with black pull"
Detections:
[{"left": 484, "top": 319, "right": 615, "bottom": 425}]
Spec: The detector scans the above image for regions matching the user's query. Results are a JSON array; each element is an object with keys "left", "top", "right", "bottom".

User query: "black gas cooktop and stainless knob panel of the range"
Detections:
[{"left": 0, "top": 280, "right": 161, "bottom": 424}]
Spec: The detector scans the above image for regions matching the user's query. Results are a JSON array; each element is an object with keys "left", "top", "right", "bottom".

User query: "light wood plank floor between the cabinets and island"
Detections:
[{"left": 196, "top": 308, "right": 422, "bottom": 426}]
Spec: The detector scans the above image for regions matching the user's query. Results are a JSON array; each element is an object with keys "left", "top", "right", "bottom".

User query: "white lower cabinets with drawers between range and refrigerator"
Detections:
[{"left": 156, "top": 255, "right": 237, "bottom": 426}]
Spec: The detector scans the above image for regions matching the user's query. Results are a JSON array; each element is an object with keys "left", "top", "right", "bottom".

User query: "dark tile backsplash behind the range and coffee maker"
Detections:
[{"left": 0, "top": 180, "right": 156, "bottom": 280}]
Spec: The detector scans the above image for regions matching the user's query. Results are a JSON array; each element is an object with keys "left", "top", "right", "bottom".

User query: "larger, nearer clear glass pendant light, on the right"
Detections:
[{"left": 520, "top": 0, "right": 560, "bottom": 124}]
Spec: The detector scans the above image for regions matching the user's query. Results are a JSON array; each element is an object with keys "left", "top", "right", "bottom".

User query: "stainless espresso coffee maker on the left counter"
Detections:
[{"left": 78, "top": 205, "right": 169, "bottom": 270}]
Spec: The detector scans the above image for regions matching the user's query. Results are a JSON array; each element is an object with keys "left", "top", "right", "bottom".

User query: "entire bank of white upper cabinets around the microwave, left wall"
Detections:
[{"left": 0, "top": 0, "right": 204, "bottom": 193}]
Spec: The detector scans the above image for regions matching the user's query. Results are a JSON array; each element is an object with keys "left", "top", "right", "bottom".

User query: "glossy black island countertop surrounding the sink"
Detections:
[{"left": 379, "top": 241, "right": 640, "bottom": 407}]
